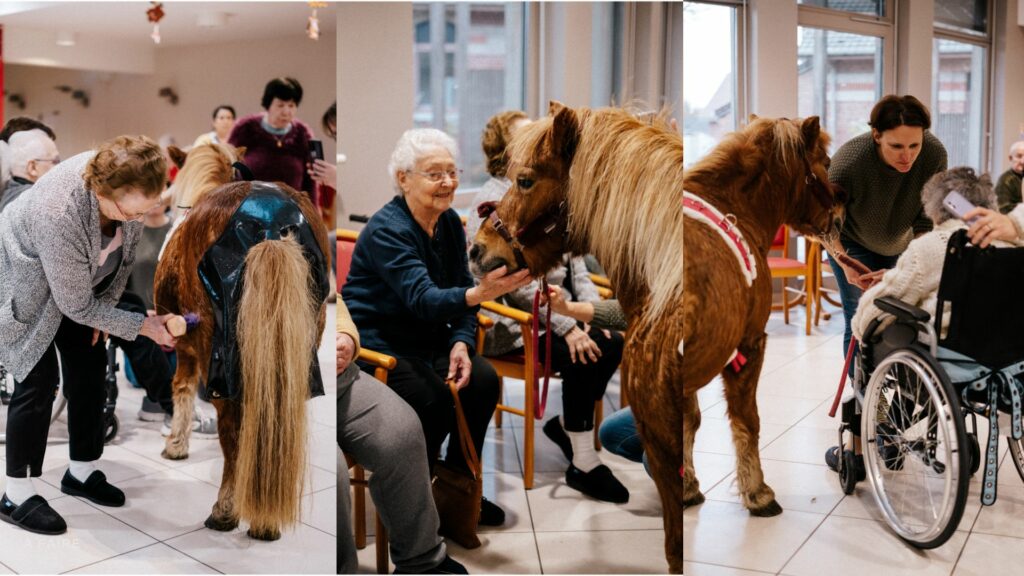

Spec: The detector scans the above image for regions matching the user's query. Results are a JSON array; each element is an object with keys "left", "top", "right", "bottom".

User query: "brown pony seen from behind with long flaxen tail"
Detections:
[{"left": 155, "top": 180, "right": 330, "bottom": 540}]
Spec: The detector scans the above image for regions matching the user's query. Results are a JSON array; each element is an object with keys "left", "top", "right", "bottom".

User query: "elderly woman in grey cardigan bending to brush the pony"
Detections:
[{"left": 0, "top": 136, "right": 175, "bottom": 534}]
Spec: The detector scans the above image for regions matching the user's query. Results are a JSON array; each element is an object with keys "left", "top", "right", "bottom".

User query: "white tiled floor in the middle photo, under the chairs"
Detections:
[{"left": 358, "top": 366, "right": 669, "bottom": 574}]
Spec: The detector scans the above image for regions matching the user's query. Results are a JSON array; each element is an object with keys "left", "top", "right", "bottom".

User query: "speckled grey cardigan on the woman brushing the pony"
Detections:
[{"left": 0, "top": 152, "right": 144, "bottom": 380}]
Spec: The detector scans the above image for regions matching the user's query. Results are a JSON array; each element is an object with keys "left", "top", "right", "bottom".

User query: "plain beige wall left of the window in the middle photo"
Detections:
[{"left": 337, "top": 2, "right": 415, "bottom": 230}]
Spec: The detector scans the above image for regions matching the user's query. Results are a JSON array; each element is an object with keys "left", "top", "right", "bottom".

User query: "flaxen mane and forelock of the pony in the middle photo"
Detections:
[{"left": 508, "top": 108, "right": 683, "bottom": 318}]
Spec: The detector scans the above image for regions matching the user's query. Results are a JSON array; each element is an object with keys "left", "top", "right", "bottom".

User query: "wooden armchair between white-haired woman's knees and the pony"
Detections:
[{"left": 476, "top": 301, "right": 604, "bottom": 490}]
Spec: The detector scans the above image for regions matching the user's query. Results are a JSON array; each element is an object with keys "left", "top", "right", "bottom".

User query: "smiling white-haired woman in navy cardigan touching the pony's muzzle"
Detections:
[{"left": 342, "top": 128, "right": 529, "bottom": 525}]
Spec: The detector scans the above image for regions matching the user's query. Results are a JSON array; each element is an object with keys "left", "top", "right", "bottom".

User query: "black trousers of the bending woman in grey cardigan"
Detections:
[{"left": 7, "top": 318, "right": 106, "bottom": 478}]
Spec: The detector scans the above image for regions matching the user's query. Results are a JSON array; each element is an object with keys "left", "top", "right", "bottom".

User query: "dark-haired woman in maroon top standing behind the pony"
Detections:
[{"left": 228, "top": 78, "right": 313, "bottom": 196}]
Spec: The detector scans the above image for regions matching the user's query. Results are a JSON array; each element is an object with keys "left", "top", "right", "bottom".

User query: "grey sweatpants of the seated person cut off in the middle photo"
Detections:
[{"left": 338, "top": 364, "right": 447, "bottom": 574}]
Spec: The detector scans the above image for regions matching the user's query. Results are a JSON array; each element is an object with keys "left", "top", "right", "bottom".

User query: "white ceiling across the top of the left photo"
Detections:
[{"left": 0, "top": 1, "right": 337, "bottom": 49}]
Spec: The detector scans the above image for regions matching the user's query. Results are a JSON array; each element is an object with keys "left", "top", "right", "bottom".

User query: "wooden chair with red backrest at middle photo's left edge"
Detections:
[{"left": 337, "top": 229, "right": 397, "bottom": 574}]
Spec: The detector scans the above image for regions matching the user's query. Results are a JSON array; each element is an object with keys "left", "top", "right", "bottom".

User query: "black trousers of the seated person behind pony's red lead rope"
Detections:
[{"left": 519, "top": 328, "right": 625, "bottom": 431}]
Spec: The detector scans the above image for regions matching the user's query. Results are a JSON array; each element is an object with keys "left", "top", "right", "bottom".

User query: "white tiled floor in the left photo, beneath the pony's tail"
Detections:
[{"left": 0, "top": 304, "right": 337, "bottom": 574}]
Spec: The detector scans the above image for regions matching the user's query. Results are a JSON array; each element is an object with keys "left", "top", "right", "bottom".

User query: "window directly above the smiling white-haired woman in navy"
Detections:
[{"left": 413, "top": 2, "right": 523, "bottom": 192}]
